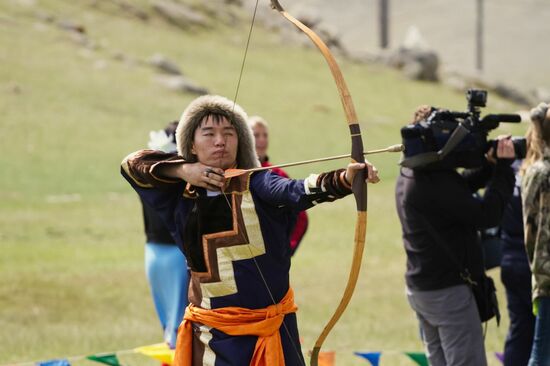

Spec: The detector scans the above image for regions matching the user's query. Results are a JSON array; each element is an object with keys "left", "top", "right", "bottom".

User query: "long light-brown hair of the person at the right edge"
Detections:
[{"left": 520, "top": 103, "right": 550, "bottom": 175}]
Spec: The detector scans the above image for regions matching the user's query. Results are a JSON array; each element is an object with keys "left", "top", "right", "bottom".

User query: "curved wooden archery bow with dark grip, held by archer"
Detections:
[{"left": 271, "top": 0, "right": 367, "bottom": 366}]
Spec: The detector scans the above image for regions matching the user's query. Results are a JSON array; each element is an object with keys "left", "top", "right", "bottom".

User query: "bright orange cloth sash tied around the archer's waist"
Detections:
[{"left": 173, "top": 288, "right": 298, "bottom": 366}]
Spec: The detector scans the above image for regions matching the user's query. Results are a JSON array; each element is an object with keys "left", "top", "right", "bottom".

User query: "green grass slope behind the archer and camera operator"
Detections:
[{"left": 0, "top": 0, "right": 523, "bottom": 365}]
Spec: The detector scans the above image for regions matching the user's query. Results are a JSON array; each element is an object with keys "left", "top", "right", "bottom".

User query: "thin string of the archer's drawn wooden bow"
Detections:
[{"left": 220, "top": 0, "right": 306, "bottom": 366}]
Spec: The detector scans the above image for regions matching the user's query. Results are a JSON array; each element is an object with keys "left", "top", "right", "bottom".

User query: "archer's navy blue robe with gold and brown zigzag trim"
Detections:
[{"left": 122, "top": 150, "right": 351, "bottom": 366}]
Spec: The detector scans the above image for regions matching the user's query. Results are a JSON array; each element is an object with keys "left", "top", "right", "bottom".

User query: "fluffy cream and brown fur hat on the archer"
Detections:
[{"left": 176, "top": 95, "right": 260, "bottom": 169}]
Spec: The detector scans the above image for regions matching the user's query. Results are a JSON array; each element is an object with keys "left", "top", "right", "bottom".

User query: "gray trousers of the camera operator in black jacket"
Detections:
[{"left": 407, "top": 285, "right": 487, "bottom": 366}]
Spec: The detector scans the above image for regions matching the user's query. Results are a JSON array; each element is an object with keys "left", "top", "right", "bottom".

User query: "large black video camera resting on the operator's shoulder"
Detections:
[{"left": 400, "top": 89, "right": 526, "bottom": 168}]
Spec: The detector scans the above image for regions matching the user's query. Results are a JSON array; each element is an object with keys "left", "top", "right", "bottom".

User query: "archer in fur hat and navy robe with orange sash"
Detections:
[{"left": 122, "top": 95, "right": 379, "bottom": 366}]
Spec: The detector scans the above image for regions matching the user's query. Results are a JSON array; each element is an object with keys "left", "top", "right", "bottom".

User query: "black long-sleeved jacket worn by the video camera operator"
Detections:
[{"left": 396, "top": 161, "right": 514, "bottom": 291}]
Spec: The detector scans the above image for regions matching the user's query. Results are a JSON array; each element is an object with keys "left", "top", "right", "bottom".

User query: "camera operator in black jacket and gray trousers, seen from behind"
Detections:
[{"left": 396, "top": 106, "right": 515, "bottom": 366}]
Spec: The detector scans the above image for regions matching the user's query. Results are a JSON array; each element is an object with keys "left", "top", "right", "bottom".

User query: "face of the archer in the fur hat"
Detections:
[{"left": 191, "top": 115, "right": 239, "bottom": 170}]
